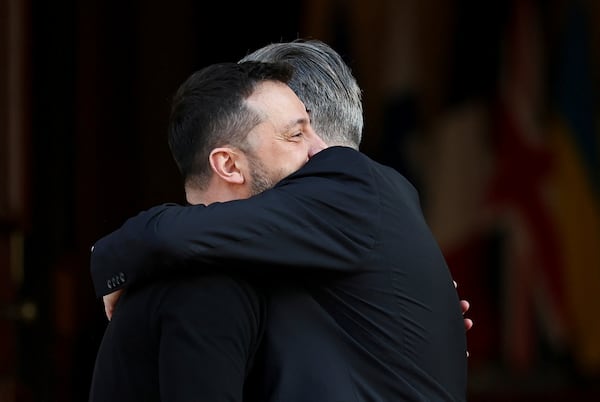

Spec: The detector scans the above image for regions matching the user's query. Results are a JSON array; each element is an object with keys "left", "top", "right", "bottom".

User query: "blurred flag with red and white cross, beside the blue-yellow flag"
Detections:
[{"left": 489, "top": 0, "right": 567, "bottom": 371}]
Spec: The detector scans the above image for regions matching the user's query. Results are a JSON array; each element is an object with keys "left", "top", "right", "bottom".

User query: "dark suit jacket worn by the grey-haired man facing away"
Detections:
[{"left": 91, "top": 147, "right": 467, "bottom": 402}]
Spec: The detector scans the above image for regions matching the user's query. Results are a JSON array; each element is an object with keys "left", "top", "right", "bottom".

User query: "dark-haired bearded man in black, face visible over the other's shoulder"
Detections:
[{"left": 90, "top": 62, "right": 325, "bottom": 402}]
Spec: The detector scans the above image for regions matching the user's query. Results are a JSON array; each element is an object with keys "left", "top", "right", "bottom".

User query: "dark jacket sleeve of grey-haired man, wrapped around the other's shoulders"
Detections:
[{"left": 91, "top": 147, "right": 380, "bottom": 296}]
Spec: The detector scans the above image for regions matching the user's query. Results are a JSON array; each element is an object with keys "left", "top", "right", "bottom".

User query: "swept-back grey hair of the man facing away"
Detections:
[{"left": 240, "top": 39, "right": 364, "bottom": 149}]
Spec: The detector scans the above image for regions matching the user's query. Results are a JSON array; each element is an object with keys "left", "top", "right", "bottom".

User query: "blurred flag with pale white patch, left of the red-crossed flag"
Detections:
[{"left": 414, "top": 0, "right": 507, "bottom": 372}]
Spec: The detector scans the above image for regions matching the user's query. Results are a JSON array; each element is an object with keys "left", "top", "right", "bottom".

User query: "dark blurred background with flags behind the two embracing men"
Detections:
[{"left": 0, "top": 0, "right": 600, "bottom": 402}]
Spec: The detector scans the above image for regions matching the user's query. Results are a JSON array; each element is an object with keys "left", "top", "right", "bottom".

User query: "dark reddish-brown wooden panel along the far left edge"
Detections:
[{"left": 0, "top": 0, "right": 32, "bottom": 402}]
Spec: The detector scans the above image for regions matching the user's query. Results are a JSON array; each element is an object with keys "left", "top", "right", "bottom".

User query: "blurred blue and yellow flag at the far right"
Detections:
[{"left": 549, "top": 2, "right": 600, "bottom": 373}]
